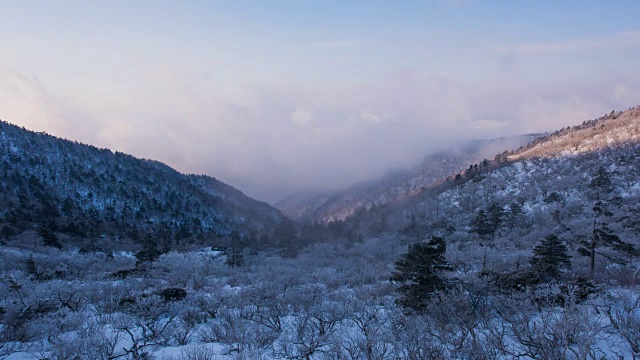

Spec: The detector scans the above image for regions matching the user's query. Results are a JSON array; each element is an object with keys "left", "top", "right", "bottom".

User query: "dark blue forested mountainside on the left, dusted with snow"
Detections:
[{"left": 0, "top": 121, "right": 293, "bottom": 252}]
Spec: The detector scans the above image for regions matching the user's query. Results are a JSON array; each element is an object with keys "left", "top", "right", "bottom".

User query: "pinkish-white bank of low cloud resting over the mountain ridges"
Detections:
[{"left": 0, "top": 66, "right": 638, "bottom": 202}]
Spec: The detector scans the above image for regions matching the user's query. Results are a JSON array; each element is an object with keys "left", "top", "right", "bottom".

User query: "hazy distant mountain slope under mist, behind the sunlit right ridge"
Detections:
[{"left": 274, "top": 134, "right": 540, "bottom": 223}]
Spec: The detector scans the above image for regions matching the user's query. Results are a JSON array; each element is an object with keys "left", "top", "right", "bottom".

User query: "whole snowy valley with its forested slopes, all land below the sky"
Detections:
[{"left": 0, "top": 107, "right": 640, "bottom": 360}]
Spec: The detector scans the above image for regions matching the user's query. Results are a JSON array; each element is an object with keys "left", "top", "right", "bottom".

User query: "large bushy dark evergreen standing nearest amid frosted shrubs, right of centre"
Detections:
[{"left": 391, "top": 236, "right": 453, "bottom": 311}]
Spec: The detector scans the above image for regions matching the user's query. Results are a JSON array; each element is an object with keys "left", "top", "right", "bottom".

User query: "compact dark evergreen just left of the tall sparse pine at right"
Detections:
[{"left": 530, "top": 234, "right": 571, "bottom": 279}]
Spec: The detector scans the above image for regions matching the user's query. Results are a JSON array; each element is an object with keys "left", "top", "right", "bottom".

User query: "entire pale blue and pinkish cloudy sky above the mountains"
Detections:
[{"left": 0, "top": 0, "right": 640, "bottom": 203}]
